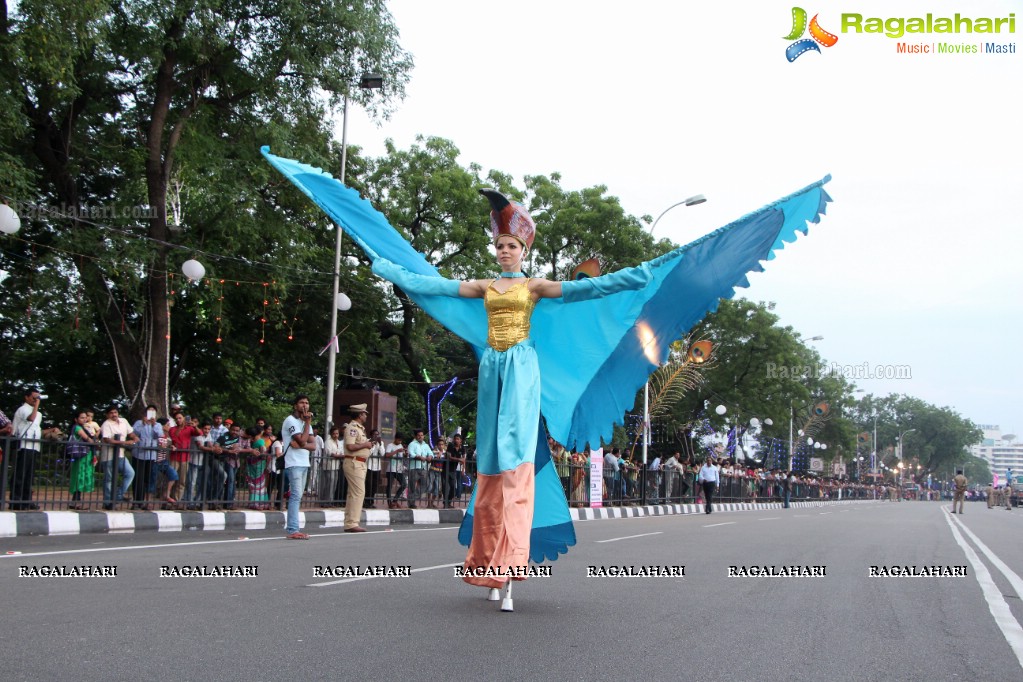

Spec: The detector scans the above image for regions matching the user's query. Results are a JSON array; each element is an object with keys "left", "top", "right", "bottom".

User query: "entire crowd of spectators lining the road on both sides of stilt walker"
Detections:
[{"left": 0, "top": 390, "right": 928, "bottom": 510}]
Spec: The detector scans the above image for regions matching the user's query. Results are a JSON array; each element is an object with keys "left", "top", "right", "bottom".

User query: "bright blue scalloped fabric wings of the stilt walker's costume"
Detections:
[{"left": 263, "top": 147, "right": 831, "bottom": 560}]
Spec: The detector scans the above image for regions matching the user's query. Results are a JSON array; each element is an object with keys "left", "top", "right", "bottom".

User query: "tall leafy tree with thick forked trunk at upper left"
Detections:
[{"left": 0, "top": 0, "right": 411, "bottom": 419}]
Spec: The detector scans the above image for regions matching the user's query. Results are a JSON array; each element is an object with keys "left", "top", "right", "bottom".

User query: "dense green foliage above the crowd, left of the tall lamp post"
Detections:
[{"left": 0, "top": 0, "right": 411, "bottom": 421}]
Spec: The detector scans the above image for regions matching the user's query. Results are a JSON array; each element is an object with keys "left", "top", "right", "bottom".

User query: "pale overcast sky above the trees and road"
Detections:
[{"left": 339, "top": 0, "right": 1023, "bottom": 433}]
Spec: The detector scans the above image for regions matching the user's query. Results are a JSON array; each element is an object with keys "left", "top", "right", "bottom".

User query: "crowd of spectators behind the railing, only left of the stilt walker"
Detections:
[{"left": 0, "top": 390, "right": 475, "bottom": 511}]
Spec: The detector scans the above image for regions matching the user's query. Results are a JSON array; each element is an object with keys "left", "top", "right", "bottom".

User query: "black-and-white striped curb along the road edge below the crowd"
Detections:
[{"left": 0, "top": 500, "right": 879, "bottom": 538}]
